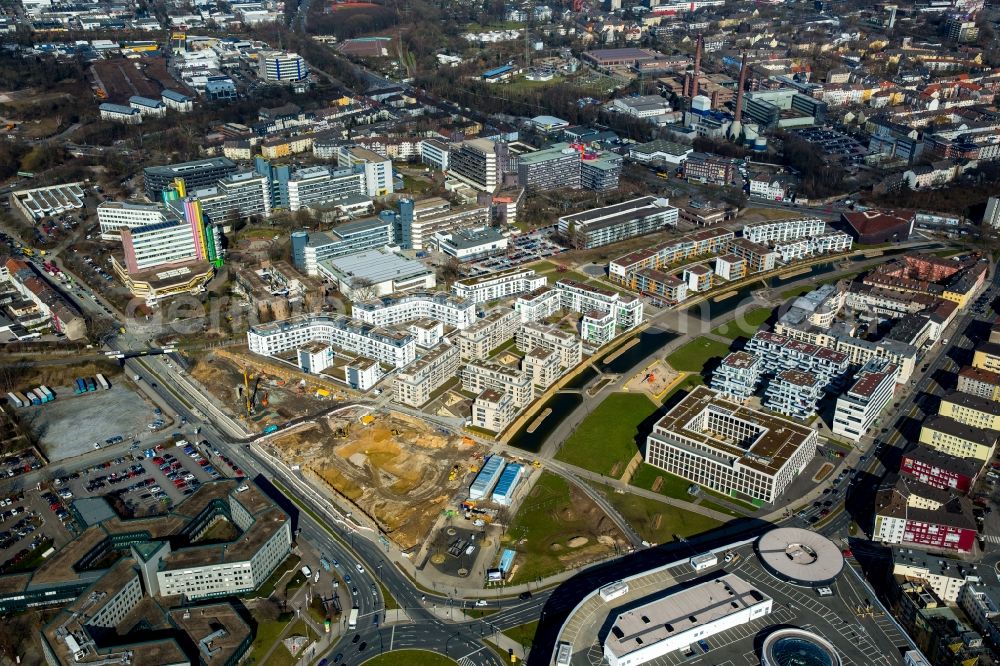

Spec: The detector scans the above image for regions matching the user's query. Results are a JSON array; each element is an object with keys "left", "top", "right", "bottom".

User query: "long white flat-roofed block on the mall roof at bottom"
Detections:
[{"left": 604, "top": 574, "right": 774, "bottom": 666}]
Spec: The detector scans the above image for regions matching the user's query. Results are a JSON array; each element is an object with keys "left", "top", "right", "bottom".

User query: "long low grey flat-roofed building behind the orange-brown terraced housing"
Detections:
[{"left": 558, "top": 197, "right": 678, "bottom": 249}]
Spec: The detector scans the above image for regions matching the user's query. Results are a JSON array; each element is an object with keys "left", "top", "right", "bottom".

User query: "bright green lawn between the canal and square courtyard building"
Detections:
[{"left": 556, "top": 393, "right": 656, "bottom": 478}]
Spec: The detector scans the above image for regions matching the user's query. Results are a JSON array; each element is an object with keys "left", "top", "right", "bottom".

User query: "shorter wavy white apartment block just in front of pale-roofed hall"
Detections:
[{"left": 351, "top": 291, "right": 476, "bottom": 330}]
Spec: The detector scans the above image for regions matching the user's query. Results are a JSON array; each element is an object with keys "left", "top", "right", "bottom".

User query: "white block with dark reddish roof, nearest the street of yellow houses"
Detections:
[{"left": 833, "top": 358, "right": 899, "bottom": 442}]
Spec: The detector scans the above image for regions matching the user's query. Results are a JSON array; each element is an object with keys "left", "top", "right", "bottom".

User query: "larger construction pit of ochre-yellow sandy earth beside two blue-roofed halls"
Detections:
[{"left": 269, "top": 407, "right": 485, "bottom": 551}]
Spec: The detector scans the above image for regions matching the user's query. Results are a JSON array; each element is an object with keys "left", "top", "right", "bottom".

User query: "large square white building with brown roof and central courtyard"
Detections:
[{"left": 646, "top": 387, "right": 818, "bottom": 502}]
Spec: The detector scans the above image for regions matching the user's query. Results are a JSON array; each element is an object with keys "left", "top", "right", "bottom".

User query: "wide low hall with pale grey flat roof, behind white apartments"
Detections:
[{"left": 317, "top": 248, "right": 437, "bottom": 301}]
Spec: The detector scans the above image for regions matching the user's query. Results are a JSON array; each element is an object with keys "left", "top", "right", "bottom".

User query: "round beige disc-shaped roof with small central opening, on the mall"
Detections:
[{"left": 754, "top": 527, "right": 844, "bottom": 587}]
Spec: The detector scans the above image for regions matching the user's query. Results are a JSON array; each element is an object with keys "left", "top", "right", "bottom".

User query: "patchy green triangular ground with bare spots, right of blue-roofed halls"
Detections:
[{"left": 503, "top": 472, "right": 625, "bottom": 584}]
